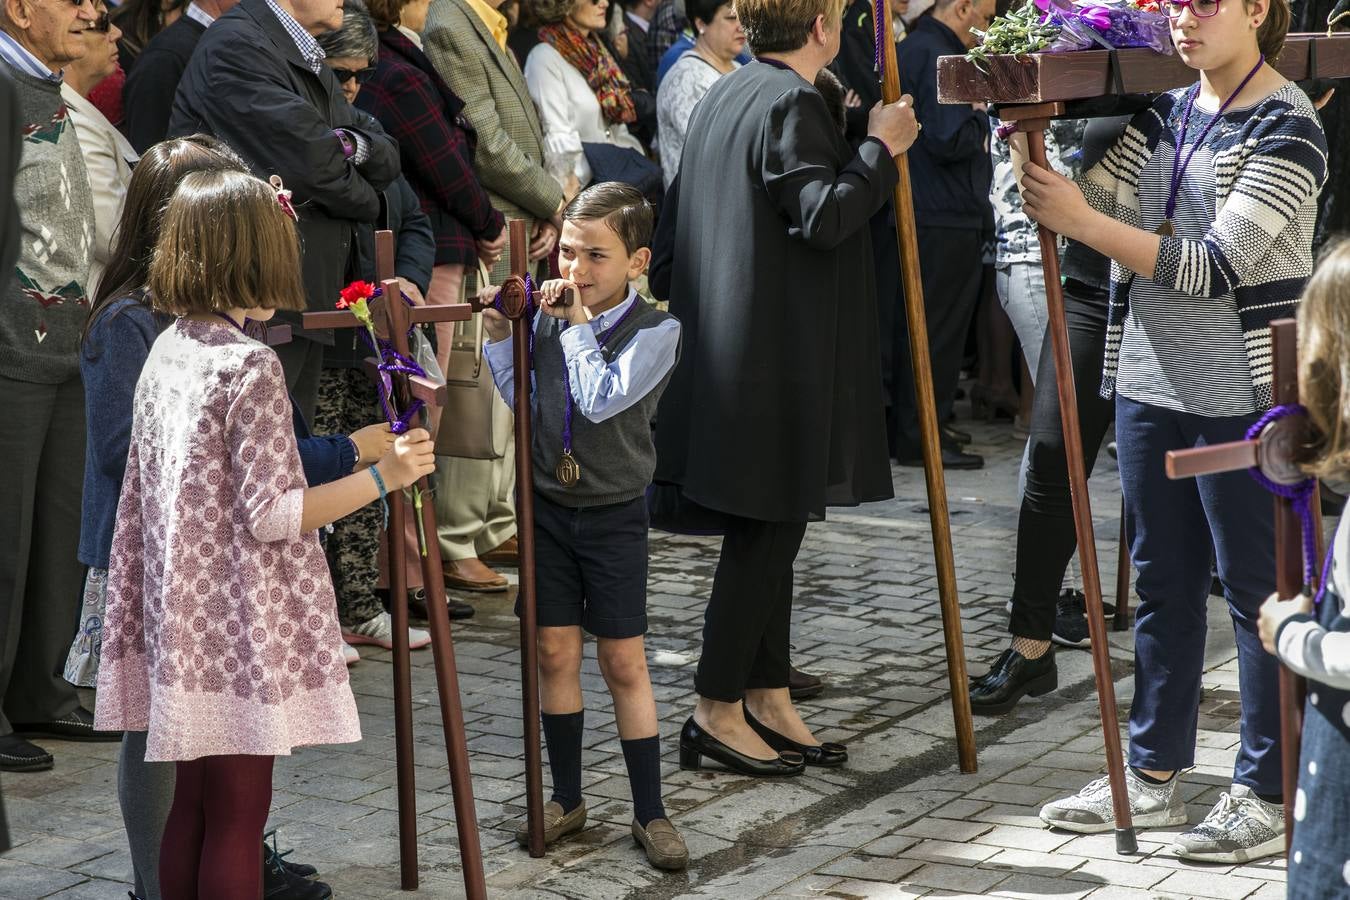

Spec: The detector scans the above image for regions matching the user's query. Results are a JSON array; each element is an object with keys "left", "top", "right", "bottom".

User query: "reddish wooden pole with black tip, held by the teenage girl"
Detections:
[{"left": 1002, "top": 112, "right": 1139, "bottom": 854}]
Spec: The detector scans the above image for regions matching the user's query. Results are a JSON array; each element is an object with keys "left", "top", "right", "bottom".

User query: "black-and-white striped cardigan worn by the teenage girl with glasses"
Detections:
[{"left": 1079, "top": 84, "right": 1327, "bottom": 409}]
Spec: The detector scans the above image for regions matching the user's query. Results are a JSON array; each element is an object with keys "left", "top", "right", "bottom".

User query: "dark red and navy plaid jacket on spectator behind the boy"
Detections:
[{"left": 356, "top": 28, "right": 505, "bottom": 266}]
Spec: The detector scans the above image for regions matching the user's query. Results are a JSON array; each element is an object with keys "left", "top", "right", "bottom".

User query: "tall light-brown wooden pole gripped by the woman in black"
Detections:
[{"left": 873, "top": 0, "right": 979, "bottom": 773}]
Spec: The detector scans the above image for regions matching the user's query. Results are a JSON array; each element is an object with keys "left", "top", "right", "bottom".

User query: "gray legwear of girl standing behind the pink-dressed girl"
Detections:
[{"left": 117, "top": 731, "right": 177, "bottom": 900}]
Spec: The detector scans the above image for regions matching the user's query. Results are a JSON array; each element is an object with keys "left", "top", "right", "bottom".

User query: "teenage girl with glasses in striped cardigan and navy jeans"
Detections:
[{"left": 1023, "top": 0, "right": 1327, "bottom": 864}]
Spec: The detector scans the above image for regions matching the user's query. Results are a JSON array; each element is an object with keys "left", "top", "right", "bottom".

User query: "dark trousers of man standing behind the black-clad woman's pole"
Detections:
[{"left": 896, "top": 227, "right": 984, "bottom": 457}]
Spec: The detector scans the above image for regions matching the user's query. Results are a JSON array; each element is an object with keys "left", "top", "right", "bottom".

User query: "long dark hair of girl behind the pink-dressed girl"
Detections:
[{"left": 81, "top": 135, "right": 248, "bottom": 345}]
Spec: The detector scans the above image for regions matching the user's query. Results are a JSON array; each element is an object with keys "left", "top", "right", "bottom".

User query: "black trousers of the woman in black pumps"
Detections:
[{"left": 694, "top": 517, "right": 806, "bottom": 703}]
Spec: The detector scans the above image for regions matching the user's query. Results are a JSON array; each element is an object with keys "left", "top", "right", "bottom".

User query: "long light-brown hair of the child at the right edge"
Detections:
[{"left": 1299, "top": 240, "right": 1350, "bottom": 479}]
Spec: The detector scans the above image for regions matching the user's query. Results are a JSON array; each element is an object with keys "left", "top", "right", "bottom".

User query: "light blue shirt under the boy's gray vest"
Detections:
[{"left": 483, "top": 287, "right": 680, "bottom": 424}]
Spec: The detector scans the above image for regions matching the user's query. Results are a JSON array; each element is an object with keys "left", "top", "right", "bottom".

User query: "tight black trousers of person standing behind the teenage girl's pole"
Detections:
[{"left": 1008, "top": 279, "right": 1123, "bottom": 641}]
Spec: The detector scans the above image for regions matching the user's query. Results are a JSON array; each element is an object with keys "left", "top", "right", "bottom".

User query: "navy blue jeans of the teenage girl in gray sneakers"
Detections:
[{"left": 1115, "top": 395, "right": 1283, "bottom": 795}]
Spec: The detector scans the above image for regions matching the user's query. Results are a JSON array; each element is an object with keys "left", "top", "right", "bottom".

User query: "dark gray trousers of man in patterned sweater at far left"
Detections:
[{"left": 0, "top": 376, "right": 85, "bottom": 735}]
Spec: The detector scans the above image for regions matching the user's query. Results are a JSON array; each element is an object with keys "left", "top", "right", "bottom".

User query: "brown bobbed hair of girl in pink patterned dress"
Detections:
[{"left": 149, "top": 171, "right": 305, "bottom": 316}]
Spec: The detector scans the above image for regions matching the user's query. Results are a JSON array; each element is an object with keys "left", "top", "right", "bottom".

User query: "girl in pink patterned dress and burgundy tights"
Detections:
[{"left": 96, "top": 171, "right": 435, "bottom": 900}]
